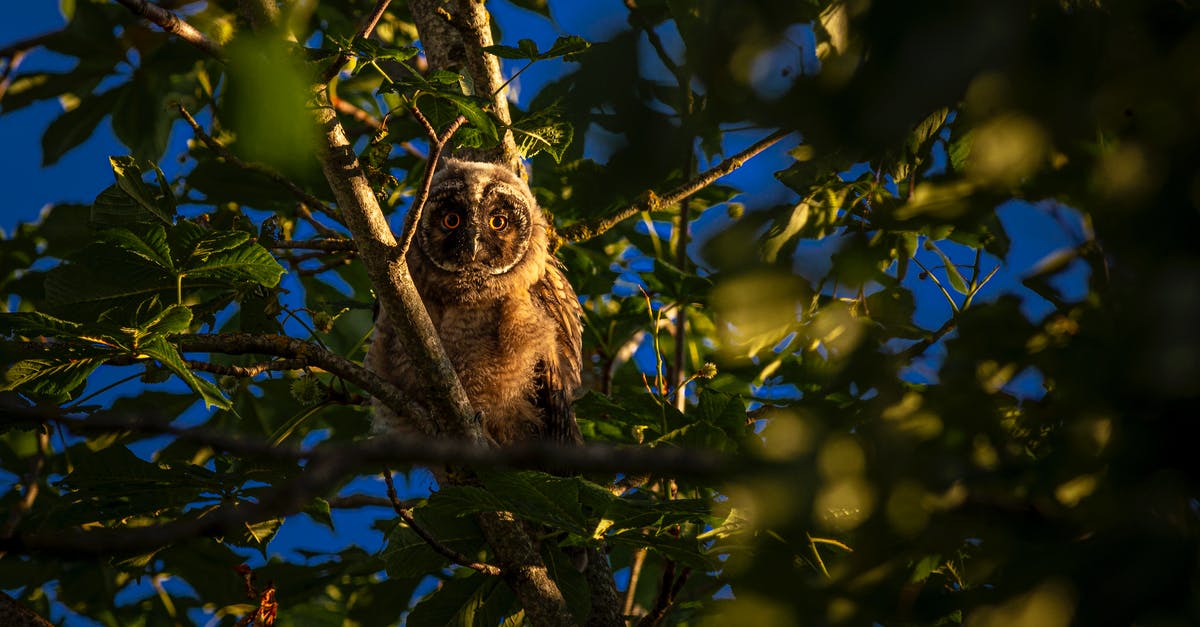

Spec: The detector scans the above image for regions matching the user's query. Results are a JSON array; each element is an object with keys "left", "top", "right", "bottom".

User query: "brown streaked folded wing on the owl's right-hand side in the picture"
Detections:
[{"left": 529, "top": 258, "right": 583, "bottom": 443}]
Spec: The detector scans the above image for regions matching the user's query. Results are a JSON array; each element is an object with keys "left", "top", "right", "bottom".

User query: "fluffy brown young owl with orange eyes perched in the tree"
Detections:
[{"left": 366, "top": 160, "right": 582, "bottom": 444}]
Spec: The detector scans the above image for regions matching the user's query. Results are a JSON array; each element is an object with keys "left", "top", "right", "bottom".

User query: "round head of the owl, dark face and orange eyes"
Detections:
[{"left": 415, "top": 160, "right": 547, "bottom": 297}]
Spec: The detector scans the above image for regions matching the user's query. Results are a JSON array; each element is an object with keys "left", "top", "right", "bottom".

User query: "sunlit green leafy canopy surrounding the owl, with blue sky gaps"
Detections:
[{"left": 0, "top": 0, "right": 1200, "bottom": 626}]
